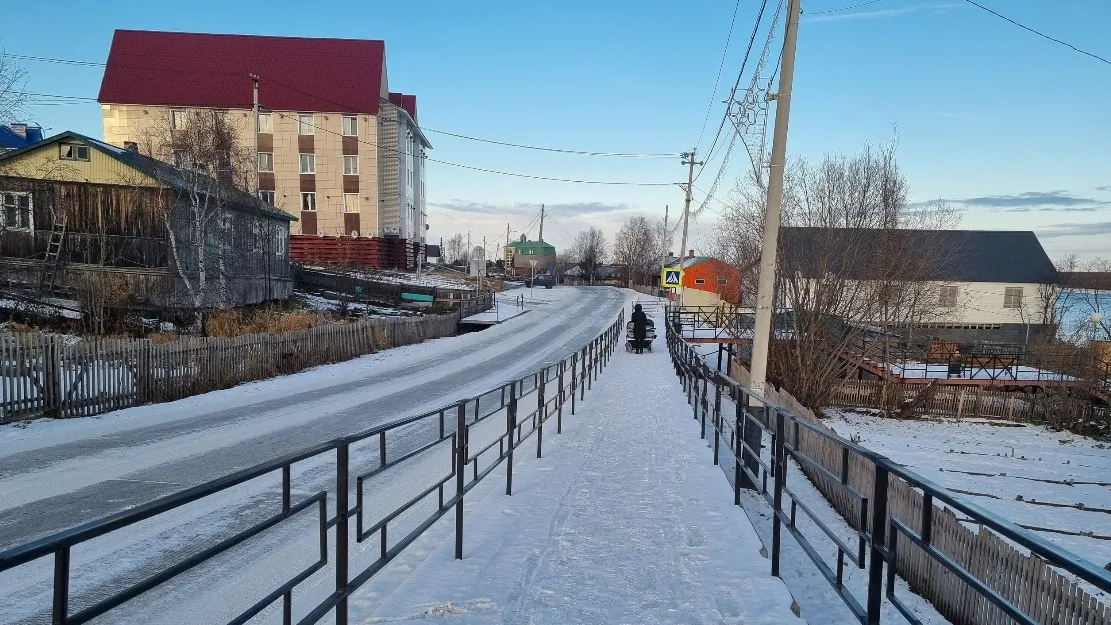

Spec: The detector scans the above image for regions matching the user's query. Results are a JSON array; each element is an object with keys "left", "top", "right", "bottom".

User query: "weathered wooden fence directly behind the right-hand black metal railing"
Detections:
[{"left": 732, "top": 361, "right": 1111, "bottom": 625}]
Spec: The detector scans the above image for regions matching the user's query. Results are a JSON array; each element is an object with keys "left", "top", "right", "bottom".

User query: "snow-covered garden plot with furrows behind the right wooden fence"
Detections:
[{"left": 828, "top": 411, "right": 1111, "bottom": 566}]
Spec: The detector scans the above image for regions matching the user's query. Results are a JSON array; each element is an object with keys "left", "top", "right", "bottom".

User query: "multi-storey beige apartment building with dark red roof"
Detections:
[{"left": 99, "top": 30, "right": 430, "bottom": 243}]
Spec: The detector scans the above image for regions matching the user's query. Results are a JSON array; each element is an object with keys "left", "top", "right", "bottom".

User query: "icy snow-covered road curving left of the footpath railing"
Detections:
[{"left": 0, "top": 288, "right": 627, "bottom": 623}]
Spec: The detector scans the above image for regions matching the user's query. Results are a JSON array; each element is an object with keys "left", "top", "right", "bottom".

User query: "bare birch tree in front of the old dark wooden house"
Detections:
[{"left": 143, "top": 110, "right": 253, "bottom": 325}]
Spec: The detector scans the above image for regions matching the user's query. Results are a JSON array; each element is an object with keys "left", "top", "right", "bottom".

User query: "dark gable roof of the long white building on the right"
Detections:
[{"left": 779, "top": 226, "right": 1057, "bottom": 283}]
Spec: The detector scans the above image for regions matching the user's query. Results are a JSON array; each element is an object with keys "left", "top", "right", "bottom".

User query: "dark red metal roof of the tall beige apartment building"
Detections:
[{"left": 97, "top": 30, "right": 391, "bottom": 115}]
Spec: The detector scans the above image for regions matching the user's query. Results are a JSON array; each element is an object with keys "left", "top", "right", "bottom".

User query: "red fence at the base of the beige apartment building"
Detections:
[{"left": 289, "top": 234, "right": 424, "bottom": 269}]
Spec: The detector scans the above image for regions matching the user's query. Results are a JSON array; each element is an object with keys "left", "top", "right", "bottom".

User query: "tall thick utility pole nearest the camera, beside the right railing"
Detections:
[{"left": 752, "top": 0, "right": 801, "bottom": 397}]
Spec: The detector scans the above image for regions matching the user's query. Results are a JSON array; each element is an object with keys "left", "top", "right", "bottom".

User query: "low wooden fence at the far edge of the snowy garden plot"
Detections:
[{"left": 832, "top": 380, "right": 1111, "bottom": 424}]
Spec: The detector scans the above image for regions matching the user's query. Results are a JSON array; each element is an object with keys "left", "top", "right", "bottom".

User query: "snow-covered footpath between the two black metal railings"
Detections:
[{"left": 351, "top": 310, "right": 802, "bottom": 625}]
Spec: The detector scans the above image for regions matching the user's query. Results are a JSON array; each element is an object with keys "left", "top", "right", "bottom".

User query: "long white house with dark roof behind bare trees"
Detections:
[{"left": 780, "top": 228, "right": 1057, "bottom": 344}]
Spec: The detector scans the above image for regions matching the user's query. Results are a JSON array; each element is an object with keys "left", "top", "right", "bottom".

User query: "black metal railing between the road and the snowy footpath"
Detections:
[{"left": 0, "top": 311, "right": 624, "bottom": 625}]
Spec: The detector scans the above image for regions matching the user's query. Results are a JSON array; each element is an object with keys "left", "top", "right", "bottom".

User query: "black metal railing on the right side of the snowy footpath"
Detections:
[{"left": 667, "top": 324, "right": 1111, "bottom": 625}]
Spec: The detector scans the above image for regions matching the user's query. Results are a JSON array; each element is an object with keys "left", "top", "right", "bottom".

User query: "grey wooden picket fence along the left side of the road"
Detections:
[{"left": 0, "top": 313, "right": 460, "bottom": 423}]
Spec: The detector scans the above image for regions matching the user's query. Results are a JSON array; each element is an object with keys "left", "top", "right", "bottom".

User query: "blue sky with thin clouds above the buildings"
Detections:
[{"left": 0, "top": 0, "right": 1111, "bottom": 256}]
